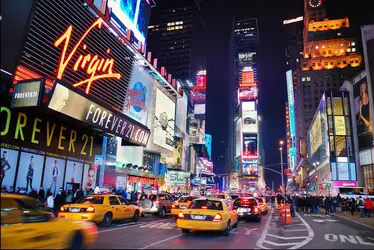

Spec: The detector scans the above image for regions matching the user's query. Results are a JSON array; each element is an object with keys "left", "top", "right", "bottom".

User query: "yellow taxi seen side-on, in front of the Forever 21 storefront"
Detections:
[{"left": 58, "top": 194, "right": 142, "bottom": 227}]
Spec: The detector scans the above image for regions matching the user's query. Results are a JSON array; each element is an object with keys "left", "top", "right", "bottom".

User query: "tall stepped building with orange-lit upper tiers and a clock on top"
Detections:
[{"left": 295, "top": 0, "right": 362, "bottom": 171}]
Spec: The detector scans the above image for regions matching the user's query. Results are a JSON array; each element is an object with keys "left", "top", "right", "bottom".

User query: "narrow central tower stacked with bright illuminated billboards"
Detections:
[{"left": 230, "top": 18, "right": 264, "bottom": 192}]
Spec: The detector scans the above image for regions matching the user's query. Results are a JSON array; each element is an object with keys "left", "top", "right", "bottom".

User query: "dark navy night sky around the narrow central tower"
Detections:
[{"left": 150, "top": 0, "right": 374, "bottom": 187}]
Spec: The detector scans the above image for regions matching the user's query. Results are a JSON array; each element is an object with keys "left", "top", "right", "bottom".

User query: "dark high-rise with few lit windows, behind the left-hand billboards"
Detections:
[{"left": 147, "top": 0, "right": 206, "bottom": 87}]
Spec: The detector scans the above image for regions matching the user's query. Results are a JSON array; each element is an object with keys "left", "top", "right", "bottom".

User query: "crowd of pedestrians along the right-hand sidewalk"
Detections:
[{"left": 272, "top": 194, "right": 373, "bottom": 218}]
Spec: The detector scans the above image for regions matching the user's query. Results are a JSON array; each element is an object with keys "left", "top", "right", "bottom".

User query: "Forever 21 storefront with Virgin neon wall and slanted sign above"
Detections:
[{"left": 0, "top": 0, "right": 150, "bottom": 193}]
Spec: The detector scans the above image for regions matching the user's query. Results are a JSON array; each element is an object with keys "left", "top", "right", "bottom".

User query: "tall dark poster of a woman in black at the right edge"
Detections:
[{"left": 353, "top": 77, "right": 373, "bottom": 149}]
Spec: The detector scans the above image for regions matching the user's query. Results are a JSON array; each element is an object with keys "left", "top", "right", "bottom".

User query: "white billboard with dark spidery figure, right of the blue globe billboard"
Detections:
[{"left": 153, "top": 89, "right": 175, "bottom": 151}]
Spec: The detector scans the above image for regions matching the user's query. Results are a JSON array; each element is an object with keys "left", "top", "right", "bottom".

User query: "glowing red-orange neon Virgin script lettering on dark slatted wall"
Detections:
[{"left": 54, "top": 18, "right": 121, "bottom": 94}]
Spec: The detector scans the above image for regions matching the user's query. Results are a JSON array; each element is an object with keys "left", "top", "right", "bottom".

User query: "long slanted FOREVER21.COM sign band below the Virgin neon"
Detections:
[{"left": 48, "top": 82, "right": 150, "bottom": 146}]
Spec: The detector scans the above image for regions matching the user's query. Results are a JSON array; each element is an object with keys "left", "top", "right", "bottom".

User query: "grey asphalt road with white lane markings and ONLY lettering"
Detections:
[{"left": 91, "top": 210, "right": 374, "bottom": 249}]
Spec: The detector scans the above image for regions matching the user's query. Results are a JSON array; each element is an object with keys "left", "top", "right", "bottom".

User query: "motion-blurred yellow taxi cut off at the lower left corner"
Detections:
[{"left": 1, "top": 194, "right": 97, "bottom": 249}]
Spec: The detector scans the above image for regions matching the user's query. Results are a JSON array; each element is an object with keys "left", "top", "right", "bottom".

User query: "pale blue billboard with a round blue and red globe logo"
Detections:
[{"left": 123, "top": 65, "right": 153, "bottom": 125}]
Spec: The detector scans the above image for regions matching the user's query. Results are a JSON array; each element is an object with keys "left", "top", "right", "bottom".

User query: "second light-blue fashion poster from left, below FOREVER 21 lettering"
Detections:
[{"left": 16, "top": 152, "right": 46, "bottom": 192}]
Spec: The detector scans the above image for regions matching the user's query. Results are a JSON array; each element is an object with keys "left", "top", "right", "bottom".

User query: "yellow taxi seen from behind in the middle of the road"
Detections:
[{"left": 177, "top": 198, "right": 238, "bottom": 236}]
